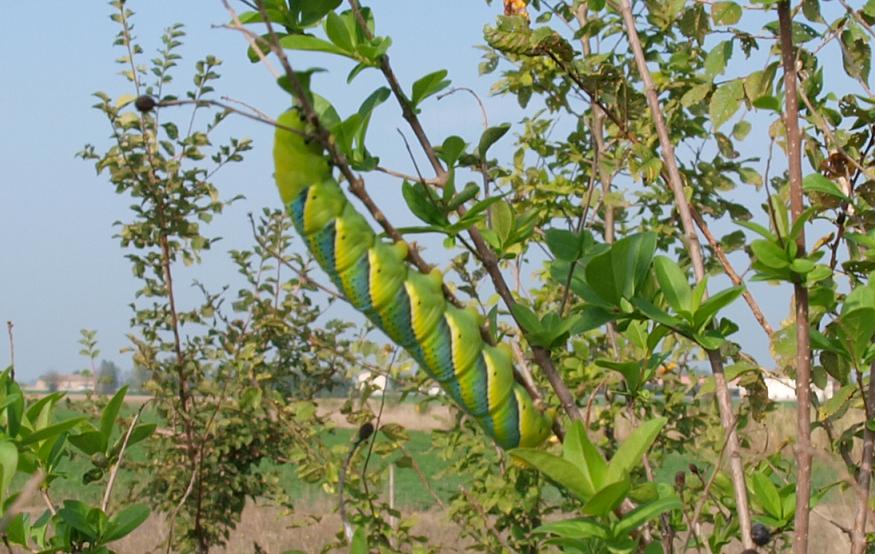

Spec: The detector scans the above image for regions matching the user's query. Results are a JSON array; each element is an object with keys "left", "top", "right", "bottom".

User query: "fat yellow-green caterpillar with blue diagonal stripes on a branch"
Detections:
[{"left": 273, "top": 108, "right": 552, "bottom": 449}]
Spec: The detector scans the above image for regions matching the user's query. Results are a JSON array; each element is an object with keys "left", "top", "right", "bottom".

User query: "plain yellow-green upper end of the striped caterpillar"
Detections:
[{"left": 273, "top": 108, "right": 331, "bottom": 204}]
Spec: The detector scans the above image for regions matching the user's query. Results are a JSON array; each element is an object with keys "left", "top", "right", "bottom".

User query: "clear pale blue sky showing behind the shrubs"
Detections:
[{"left": 0, "top": 0, "right": 856, "bottom": 379}]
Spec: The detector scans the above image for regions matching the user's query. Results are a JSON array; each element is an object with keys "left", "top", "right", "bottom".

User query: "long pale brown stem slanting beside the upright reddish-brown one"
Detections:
[{"left": 619, "top": 0, "right": 755, "bottom": 548}]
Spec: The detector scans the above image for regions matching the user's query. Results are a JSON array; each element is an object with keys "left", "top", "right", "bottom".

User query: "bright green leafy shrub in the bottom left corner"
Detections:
[{"left": 0, "top": 368, "right": 155, "bottom": 553}]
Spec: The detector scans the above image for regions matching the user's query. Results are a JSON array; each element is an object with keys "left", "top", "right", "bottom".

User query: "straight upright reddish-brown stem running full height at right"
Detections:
[{"left": 778, "top": 0, "right": 811, "bottom": 554}]
